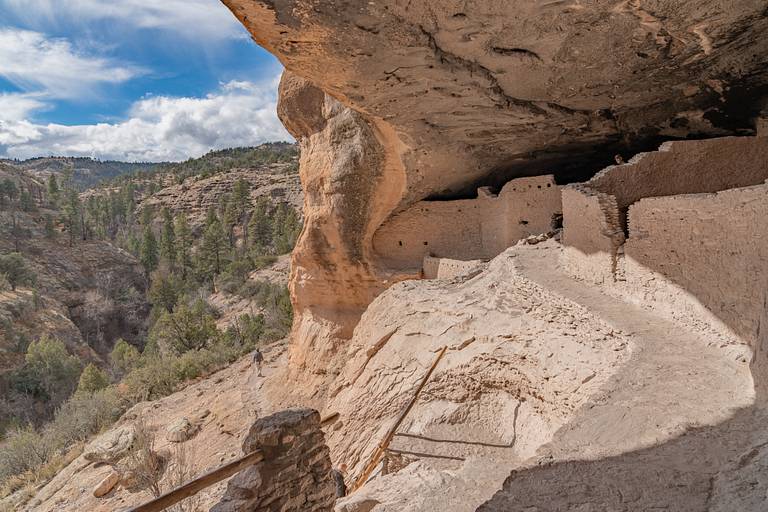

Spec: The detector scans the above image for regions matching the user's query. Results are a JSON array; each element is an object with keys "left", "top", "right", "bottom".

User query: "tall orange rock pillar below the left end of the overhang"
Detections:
[{"left": 278, "top": 73, "right": 404, "bottom": 382}]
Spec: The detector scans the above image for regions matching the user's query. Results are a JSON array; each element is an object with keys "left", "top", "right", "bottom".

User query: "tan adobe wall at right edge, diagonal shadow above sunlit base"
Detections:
[{"left": 624, "top": 184, "right": 768, "bottom": 345}]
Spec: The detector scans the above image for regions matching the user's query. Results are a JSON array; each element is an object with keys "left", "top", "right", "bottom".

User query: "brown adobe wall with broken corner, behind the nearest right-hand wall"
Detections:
[{"left": 562, "top": 137, "right": 768, "bottom": 282}]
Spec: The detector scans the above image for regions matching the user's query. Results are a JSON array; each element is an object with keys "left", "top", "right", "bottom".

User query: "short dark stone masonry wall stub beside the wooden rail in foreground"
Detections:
[{"left": 211, "top": 409, "right": 336, "bottom": 512}]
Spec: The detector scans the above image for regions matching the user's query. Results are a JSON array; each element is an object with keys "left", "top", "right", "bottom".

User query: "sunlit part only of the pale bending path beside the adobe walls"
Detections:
[{"left": 517, "top": 242, "right": 754, "bottom": 458}]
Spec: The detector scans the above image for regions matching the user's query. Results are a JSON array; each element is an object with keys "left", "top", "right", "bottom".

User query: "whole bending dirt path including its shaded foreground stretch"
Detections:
[{"left": 478, "top": 245, "right": 768, "bottom": 512}]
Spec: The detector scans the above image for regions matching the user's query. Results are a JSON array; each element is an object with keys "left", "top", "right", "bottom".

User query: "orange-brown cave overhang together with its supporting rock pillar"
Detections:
[{"left": 223, "top": 0, "right": 768, "bottom": 373}]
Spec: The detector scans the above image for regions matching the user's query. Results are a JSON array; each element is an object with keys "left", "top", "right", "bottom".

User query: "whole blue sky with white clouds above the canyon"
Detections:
[{"left": 0, "top": 0, "right": 290, "bottom": 161}]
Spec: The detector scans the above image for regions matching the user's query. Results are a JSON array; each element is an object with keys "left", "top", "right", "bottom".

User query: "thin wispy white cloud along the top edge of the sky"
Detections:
[{"left": 4, "top": 0, "right": 246, "bottom": 40}]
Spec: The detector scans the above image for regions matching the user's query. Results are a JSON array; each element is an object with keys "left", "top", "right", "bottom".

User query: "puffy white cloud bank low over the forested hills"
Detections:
[{"left": 0, "top": 78, "right": 291, "bottom": 162}]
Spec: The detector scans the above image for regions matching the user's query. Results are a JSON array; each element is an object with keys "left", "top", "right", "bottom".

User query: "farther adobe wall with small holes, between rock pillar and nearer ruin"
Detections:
[{"left": 373, "top": 175, "right": 562, "bottom": 269}]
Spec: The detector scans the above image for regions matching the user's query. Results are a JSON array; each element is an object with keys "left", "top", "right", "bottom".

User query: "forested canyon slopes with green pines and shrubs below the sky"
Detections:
[{"left": 0, "top": 144, "right": 301, "bottom": 504}]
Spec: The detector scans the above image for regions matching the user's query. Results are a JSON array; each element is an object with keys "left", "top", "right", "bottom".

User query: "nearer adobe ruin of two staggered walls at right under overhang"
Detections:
[{"left": 562, "top": 137, "right": 768, "bottom": 342}]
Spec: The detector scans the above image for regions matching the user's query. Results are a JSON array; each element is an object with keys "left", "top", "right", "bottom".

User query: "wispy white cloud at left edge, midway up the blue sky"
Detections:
[{"left": 0, "top": 28, "right": 142, "bottom": 98}]
